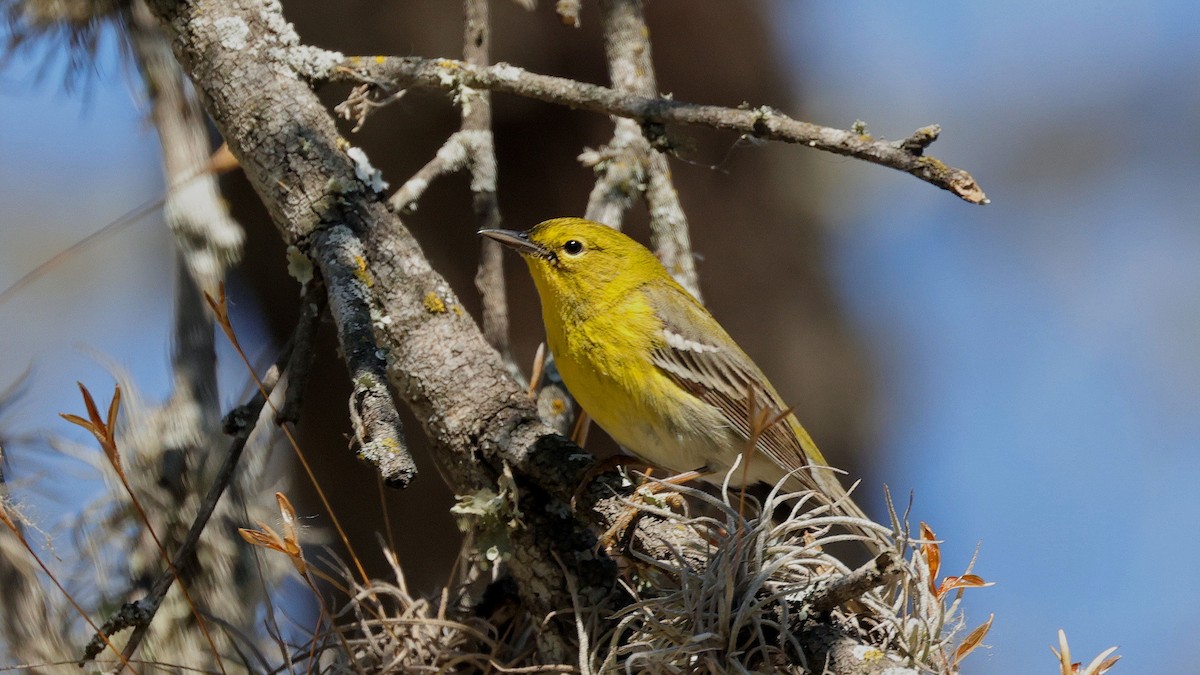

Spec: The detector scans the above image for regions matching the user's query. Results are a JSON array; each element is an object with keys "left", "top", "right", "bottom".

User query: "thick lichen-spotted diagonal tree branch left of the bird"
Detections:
[{"left": 152, "top": 0, "right": 623, "bottom": 662}]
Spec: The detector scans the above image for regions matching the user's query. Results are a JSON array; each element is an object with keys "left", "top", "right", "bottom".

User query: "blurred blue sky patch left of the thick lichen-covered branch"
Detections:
[{"left": 0, "top": 36, "right": 172, "bottom": 514}]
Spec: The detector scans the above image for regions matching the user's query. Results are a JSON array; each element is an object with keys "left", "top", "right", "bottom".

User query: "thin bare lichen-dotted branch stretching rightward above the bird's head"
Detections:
[{"left": 333, "top": 56, "right": 988, "bottom": 204}]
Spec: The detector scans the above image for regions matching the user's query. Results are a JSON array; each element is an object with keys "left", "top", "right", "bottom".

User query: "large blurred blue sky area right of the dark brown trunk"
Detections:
[{"left": 776, "top": 1, "right": 1200, "bottom": 674}]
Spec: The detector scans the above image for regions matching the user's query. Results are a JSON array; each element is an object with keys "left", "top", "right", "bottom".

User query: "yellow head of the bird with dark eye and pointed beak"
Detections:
[{"left": 480, "top": 217, "right": 671, "bottom": 309}]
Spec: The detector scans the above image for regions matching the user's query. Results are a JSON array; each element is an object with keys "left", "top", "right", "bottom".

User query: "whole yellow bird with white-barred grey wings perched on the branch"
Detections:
[{"left": 480, "top": 217, "right": 877, "bottom": 550}]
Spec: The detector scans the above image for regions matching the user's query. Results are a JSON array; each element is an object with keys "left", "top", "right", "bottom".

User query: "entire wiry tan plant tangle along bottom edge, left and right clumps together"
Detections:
[{"left": 278, "top": 468, "right": 990, "bottom": 673}]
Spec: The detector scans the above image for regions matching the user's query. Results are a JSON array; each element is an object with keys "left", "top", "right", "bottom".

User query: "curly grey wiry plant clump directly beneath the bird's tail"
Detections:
[{"left": 580, "top": 475, "right": 982, "bottom": 673}]
